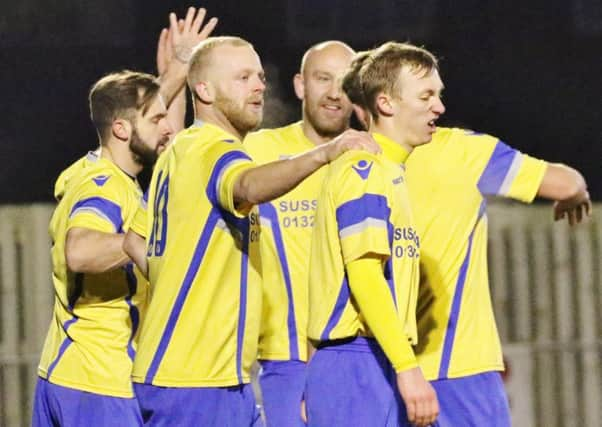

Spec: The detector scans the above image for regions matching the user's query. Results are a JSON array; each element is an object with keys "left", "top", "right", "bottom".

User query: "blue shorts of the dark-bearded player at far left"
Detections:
[{"left": 31, "top": 378, "right": 142, "bottom": 427}]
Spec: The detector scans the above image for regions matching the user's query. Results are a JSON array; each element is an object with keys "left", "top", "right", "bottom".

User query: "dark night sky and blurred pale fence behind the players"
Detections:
[{"left": 0, "top": 0, "right": 602, "bottom": 427}]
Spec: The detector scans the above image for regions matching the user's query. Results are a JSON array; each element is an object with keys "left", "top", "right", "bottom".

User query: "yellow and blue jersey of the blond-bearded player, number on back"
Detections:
[{"left": 132, "top": 122, "right": 261, "bottom": 387}]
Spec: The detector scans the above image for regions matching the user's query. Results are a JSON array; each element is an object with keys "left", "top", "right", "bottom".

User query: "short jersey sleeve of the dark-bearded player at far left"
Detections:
[{"left": 67, "top": 175, "right": 125, "bottom": 233}]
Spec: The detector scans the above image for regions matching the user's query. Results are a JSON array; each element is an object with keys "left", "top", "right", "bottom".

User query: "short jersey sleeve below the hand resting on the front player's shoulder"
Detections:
[{"left": 330, "top": 156, "right": 391, "bottom": 265}]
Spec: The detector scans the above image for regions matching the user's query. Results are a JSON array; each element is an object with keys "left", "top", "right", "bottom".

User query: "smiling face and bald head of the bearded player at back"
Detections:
[{"left": 295, "top": 42, "right": 354, "bottom": 138}]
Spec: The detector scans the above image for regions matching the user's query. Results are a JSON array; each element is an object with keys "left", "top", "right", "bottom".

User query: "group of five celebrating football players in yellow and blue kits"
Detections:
[{"left": 32, "top": 8, "right": 591, "bottom": 427}]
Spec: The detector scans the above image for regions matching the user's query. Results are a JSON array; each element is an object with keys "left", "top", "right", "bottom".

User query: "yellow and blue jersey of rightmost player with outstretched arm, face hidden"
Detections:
[{"left": 406, "top": 128, "right": 546, "bottom": 380}]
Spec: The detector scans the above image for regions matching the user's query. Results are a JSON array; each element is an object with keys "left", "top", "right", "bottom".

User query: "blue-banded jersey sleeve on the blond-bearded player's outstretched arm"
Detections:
[{"left": 209, "top": 140, "right": 255, "bottom": 217}]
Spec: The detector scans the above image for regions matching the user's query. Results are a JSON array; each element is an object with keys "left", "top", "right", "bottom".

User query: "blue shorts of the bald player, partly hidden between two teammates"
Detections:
[{"left": 259, "top": 360, "right": 306, "bottom": 427}]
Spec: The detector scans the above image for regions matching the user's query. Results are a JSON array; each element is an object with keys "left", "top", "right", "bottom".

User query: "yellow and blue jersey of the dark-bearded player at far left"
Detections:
[{"left": 38, "top": 153, "right": 148, "bottom": 397}]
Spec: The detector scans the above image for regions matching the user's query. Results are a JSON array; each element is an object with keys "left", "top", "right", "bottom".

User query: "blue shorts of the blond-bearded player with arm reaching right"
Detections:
[{"left": 134, "top": 383, "right": 263, "bottom": 427}]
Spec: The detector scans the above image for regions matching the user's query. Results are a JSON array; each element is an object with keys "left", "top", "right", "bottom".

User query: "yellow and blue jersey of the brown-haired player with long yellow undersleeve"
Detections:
[{"left": 308, "top": 134, "right": 421, "bottom": 343}]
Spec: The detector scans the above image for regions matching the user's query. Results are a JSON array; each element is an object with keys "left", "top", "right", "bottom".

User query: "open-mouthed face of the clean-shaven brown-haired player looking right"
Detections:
[{"left": 391, "top": 66, "right": 445, "bottom": 147}]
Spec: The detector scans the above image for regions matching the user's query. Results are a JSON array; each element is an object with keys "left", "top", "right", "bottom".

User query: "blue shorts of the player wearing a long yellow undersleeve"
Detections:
[{"left": 305, "top": 338, "right": 409, "bottom": 427}]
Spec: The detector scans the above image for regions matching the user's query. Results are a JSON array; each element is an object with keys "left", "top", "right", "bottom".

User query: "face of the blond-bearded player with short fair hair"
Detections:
[{"left": 210, "top": 44, "right": 265, "bottom": 134}]
